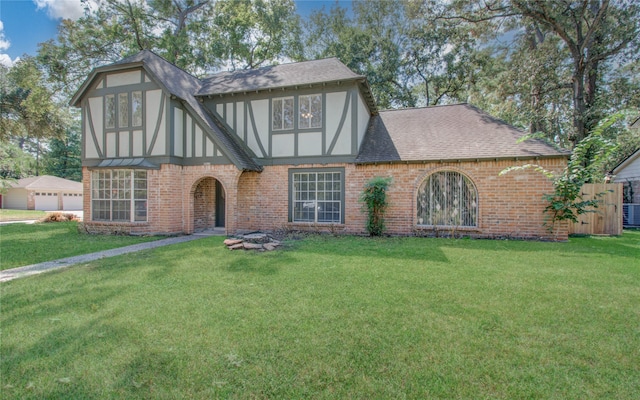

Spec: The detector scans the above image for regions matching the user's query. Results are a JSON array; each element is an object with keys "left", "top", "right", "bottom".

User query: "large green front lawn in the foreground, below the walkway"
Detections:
[{"left": 0, "top": 232, "right": 640, "bottom": 399}]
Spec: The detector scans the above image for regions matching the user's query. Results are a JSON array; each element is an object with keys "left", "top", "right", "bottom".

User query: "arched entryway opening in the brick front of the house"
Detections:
[{"left": 193, "top": 177, "right": 226, "bottom": 232}]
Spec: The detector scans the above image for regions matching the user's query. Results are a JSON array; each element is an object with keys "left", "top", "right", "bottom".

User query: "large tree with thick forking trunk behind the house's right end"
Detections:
[{"left": 441, "top": 0, "right": 640, "bottom": 144}]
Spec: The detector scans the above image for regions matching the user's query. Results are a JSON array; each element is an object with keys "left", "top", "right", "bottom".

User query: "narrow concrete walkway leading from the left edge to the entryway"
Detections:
[{"left": 0, "top": 231, "right": 219, "bottom": 282}]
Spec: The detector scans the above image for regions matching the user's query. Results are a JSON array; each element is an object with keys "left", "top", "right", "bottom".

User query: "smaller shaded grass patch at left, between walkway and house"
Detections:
[{"left": 0, "top": 222, "right": 158, "bottom": 270}]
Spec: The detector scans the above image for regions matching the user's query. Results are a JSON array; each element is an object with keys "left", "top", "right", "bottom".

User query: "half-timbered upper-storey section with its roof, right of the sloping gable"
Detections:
[{"left": 198, "top": 58, "right": 376, "bottom": 164}]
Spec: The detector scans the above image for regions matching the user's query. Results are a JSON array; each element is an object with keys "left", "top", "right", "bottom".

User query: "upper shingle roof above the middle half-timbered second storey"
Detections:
[{"left": 197, "top": 58, "right": 365, "bottom": 96}]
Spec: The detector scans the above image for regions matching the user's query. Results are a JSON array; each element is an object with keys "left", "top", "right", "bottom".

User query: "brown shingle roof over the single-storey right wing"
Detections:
[{"left": 356, "top": 104, "right": 567, "bottom": 163}]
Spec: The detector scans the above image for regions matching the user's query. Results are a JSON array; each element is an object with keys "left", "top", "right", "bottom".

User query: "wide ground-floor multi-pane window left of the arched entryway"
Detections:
[{"left": 91, "top": 169, "right": 147, "bottom": 222}]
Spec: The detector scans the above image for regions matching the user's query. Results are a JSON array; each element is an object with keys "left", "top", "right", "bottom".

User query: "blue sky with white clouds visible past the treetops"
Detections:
[{"left": 0, "top": 0, "right": 349, "bottom": 65}]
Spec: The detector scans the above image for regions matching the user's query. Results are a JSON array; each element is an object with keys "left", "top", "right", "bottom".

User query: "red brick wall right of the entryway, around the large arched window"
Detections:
[{"left": 232, "top": 159, "right": 567, "bottom": 240}]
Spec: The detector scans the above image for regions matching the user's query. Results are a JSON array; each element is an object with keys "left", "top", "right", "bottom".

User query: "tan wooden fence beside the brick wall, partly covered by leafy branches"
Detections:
[{"left": 569, "top": 183, "right": 622, "bottom": 235}]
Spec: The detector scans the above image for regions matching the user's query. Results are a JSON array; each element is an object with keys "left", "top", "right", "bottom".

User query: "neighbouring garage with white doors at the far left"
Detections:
[{"left": 2, "top": 175, "right": 82, "bottom": 211}]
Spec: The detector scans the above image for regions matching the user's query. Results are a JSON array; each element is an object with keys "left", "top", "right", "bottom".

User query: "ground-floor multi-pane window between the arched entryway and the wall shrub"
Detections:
[{"left": 289, "top": 169, "right": 344, "bottom": 223}]
